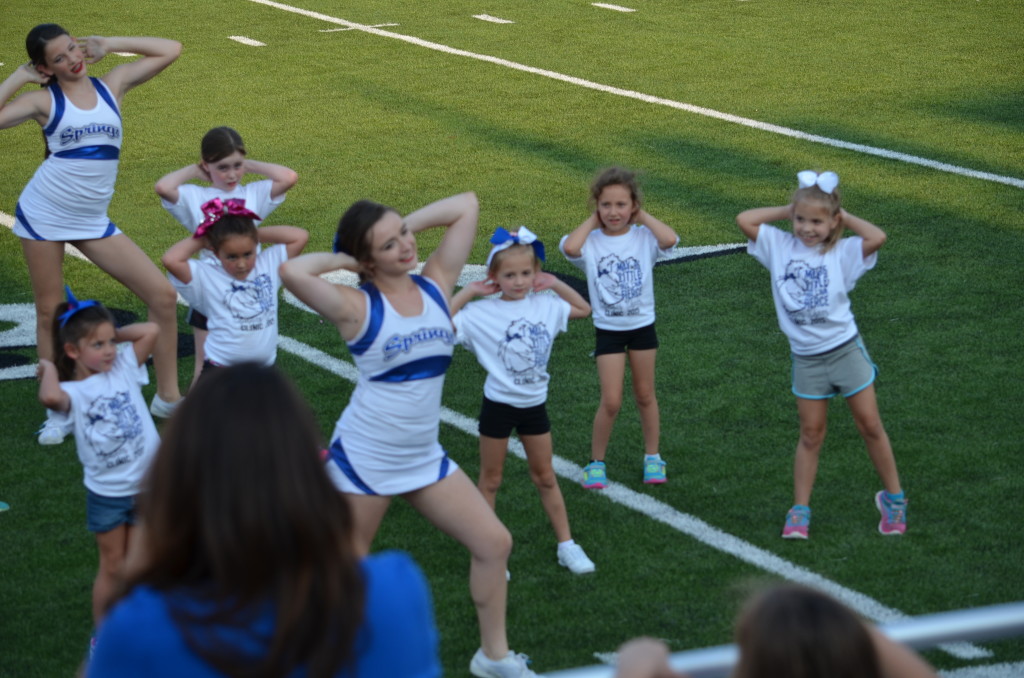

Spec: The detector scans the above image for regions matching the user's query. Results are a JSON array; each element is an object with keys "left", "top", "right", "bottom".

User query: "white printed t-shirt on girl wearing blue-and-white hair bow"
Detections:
[{"left": 452, "top": 293, "right": 572, "bottom": 408}]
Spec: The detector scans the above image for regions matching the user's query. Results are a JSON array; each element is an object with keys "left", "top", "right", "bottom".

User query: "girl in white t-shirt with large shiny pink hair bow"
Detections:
[{"left": 162, "top": 198, "right": 309, "bottom": 373}]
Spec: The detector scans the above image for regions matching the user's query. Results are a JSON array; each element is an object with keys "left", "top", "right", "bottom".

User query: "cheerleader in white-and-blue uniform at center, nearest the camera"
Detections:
[{"left": 281, "top": 193, "right": 536, "bottom": 678}]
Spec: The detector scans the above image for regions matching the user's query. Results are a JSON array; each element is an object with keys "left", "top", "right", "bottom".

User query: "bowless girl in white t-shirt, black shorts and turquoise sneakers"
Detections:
[{"left": 559, "top": 167, "right": 679, "bottom": 490}]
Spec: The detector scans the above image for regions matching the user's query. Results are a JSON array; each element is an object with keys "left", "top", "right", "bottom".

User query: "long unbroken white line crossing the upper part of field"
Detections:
[{"left": 249, "top": 0, "right": 1024, "bottom": 188}]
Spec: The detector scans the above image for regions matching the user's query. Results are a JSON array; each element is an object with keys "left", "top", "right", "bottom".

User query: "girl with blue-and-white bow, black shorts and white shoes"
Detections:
[{"left": 452, "top": 231, "right": 594, "bottom": 575}]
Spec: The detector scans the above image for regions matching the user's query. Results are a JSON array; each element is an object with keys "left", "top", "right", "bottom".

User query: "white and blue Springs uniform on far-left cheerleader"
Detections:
[{"left": 14, "top": 77, "right": 122, "bottom": 242}]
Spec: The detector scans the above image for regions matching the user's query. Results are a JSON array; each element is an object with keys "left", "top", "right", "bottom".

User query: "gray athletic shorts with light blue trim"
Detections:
[{"left": 793, "top": 335, "right": 879, "bottom": 400}]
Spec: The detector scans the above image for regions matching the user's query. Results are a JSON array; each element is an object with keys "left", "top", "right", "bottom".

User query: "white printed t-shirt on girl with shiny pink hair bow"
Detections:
[{"left": 167, "top": 245, "right": 288, "bottom": 366}]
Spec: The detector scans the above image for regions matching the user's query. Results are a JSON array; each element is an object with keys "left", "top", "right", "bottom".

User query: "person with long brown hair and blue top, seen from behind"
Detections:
[{"left": 89, "top": 364, "right": 441, "bottom": 678}]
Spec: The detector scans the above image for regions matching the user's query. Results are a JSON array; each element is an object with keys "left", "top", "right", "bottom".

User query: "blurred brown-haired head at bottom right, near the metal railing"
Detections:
[{"left": 733, "top": 584, "right": 882, "bottom": 678}]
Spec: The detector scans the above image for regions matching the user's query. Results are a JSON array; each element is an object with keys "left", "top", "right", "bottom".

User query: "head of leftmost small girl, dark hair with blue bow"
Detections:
[{"left": 52, "top": 286, "right": 117, "bottom": 381}]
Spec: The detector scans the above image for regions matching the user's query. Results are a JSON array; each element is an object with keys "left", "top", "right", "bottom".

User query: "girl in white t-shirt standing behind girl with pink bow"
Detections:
[{"left": 154, "top": 127, "right": 299, "bottom": 393}]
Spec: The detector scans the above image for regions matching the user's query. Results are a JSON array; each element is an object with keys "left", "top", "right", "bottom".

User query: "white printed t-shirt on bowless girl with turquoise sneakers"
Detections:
[{"left": 558, "top": 224, "right": 679, "bottom": 331}]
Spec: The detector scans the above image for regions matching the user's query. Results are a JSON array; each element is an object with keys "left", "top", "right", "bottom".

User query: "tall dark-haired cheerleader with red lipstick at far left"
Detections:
[{"left": 0, "top": 24, "right": 181, "bottom": 444}]
